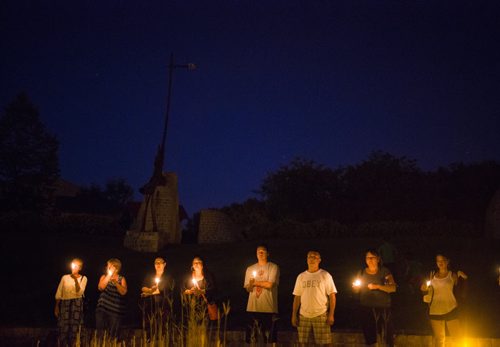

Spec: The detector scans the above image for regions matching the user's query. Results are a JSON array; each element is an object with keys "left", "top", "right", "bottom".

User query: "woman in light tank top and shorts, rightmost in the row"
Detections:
[{"left": 420, "top": 253, "right": 467, "bottom": 347}]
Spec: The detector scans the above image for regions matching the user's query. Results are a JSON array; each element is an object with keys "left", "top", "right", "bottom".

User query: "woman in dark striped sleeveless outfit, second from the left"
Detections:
[{"left": 95, "top": 258, "right": 127, "bottom": 338}]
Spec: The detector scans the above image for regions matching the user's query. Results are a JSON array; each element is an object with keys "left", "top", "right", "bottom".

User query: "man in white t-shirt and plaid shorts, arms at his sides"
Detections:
[{"left": 292, "top": 251, "right": 337, "bottom": 345}]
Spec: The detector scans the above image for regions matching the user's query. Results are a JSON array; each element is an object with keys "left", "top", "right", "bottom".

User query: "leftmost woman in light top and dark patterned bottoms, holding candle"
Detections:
[{"left": 54, "top": 258, "right": 87, "bottom": 346}]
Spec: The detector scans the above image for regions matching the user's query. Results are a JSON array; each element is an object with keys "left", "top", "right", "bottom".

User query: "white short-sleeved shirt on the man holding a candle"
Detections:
[{"left": 243, "top": 262, "right": 280, "bottom": 313}]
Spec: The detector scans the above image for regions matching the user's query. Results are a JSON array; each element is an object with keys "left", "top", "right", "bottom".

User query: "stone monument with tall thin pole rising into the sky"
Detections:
[{"left": 124, "top": 55, "right": 195, "bottom": 252}]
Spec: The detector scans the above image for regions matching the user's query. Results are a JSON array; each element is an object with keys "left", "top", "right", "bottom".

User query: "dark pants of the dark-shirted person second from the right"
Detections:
[{"left": 360, "top": 306, "right": 394, "bottom": 347}]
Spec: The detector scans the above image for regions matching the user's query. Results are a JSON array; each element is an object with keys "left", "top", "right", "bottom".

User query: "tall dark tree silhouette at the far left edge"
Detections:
[{"left": 0, "top": 93, "right": 59, "bottom": 212}]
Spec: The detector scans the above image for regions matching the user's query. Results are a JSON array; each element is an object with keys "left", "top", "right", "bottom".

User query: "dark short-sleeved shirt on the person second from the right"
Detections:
[{"left": 360, "top": 266, "right": 391, "bottom": 308}]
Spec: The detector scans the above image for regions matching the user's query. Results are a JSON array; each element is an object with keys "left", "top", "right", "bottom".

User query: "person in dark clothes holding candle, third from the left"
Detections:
[{"left": 141, "top": 257, "right": 173, "bottom": 320}]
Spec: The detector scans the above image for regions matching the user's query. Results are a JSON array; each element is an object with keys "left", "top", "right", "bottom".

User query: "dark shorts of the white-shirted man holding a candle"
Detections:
[{"left": 245, "top": 312, "right": 279, "bottom": 343}]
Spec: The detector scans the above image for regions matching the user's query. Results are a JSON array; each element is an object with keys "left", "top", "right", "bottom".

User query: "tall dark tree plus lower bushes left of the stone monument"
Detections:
[{"left": 0, "top": 93, "right": 133, "bottom": 226}]
